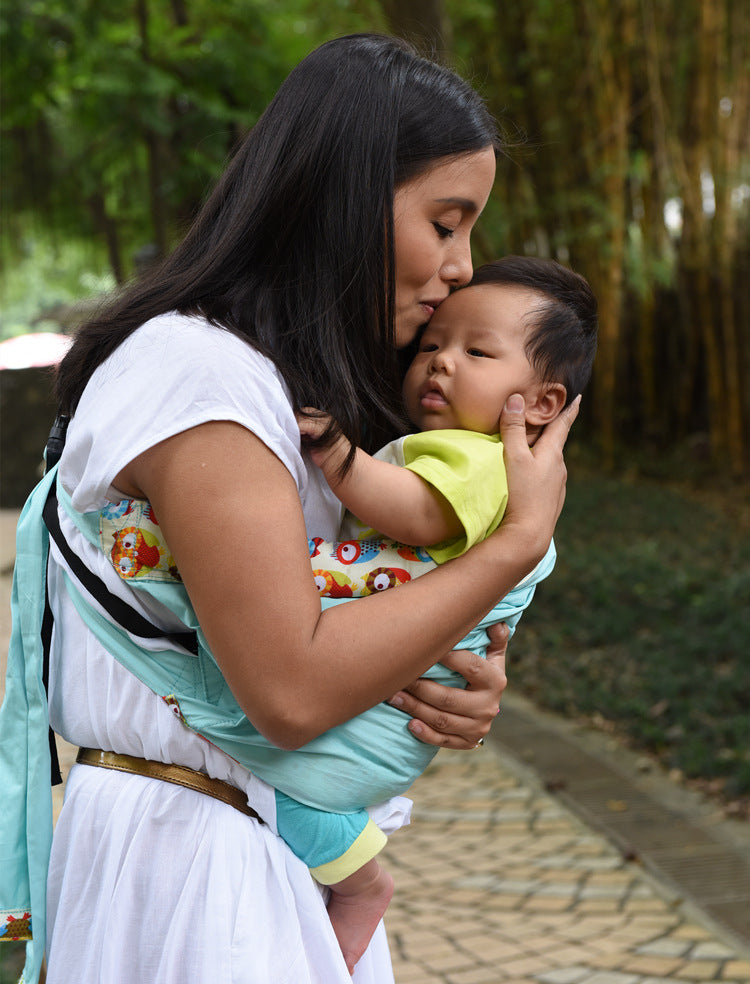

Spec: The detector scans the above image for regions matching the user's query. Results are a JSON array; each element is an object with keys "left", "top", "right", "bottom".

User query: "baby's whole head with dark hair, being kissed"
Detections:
[{"left": 404, "top": 256, "right": 597, "bottom": 436}]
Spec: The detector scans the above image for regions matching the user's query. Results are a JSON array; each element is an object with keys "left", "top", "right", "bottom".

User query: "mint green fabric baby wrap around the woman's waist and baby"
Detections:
[{"left": 58, "top": 472, "right": 555, "bottom": 813}]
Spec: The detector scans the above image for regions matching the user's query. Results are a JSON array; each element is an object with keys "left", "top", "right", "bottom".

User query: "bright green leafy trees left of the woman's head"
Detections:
[{"left": 0, "top": 0, "right": 378, "bottom": 276}]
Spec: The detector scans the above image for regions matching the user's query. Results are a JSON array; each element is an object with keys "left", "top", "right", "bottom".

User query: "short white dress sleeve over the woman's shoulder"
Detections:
[{"left": 60, "top": 314, "right": 307, "bottom": 512}]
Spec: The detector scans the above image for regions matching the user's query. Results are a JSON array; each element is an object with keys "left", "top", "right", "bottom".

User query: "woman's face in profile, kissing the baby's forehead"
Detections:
[{"left": 393, "top": 147, "right": 495, "bottom": 348}]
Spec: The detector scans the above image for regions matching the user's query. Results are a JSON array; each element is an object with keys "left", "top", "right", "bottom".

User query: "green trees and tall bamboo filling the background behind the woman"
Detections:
[{"left": 0, "top": 0, "right": 750, "bottom": 474}]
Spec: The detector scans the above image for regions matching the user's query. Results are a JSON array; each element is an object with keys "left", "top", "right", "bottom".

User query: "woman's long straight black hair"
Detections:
[{"left": 57, "top": 34, "right": 498, "bottom": 448}]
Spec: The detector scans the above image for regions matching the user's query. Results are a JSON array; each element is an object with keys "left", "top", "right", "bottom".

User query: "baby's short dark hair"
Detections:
[{"left": 468, "top": 256, "right": 598, "bottom": 406}]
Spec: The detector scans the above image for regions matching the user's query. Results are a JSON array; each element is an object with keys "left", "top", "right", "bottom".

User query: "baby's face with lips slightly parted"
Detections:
[{"left": 404, "top": 284, "right": 543, "bottom": 434}]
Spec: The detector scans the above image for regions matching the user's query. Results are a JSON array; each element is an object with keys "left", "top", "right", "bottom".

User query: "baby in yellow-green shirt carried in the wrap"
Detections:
[{"left": 294, "top": 257, "right": 597, "bottom": 970}]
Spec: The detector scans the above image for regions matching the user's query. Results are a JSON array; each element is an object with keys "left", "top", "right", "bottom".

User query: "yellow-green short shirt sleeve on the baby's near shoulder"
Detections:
[{"left": 402, "top": 430, "right": 508, "bottom": 564}]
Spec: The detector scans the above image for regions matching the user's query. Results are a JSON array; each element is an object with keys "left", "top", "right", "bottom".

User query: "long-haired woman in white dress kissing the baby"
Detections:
[{"left": 13, "top": 36, "right": 572, "bottom": 984}]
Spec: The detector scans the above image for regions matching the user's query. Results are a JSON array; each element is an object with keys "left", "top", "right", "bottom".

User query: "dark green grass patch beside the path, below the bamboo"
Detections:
[{"left": 509, "top": 454, "right": 750, "bottom": 800}]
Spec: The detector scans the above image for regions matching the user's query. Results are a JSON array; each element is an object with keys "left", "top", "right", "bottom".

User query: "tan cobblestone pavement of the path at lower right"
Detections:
[{"left": 384, "top": 742, "right": 750, "bottom": 984}]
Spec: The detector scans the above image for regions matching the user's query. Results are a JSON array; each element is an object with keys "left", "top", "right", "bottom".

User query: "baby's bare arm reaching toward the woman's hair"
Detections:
[{"left": 298, "top": 411, "right": 463, "bottom": 546}]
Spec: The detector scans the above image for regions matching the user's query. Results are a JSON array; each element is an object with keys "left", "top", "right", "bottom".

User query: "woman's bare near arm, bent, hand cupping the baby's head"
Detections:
[{"left": 116, "top": 392, "right": 575, "bottom": 748}]
